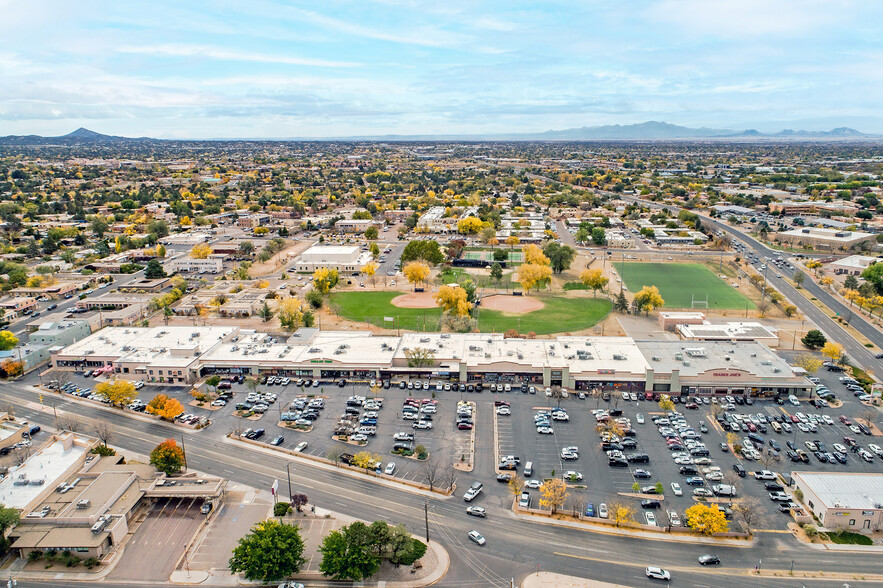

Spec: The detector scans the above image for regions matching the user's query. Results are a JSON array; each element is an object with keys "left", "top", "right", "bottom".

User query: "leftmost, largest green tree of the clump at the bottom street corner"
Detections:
[{"left": 319, "top": 521, "right": 380, "bottom": 581}]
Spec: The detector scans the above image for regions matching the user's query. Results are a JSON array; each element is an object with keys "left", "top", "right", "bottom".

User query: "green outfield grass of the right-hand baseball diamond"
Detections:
[{"left": 478, "top": 296, "right": 613, "bottom": 335}]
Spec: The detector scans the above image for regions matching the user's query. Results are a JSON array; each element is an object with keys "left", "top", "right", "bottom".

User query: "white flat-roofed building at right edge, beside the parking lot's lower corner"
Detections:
[{"left": 791, "top": 472, "right": 883, "bottom": 533}]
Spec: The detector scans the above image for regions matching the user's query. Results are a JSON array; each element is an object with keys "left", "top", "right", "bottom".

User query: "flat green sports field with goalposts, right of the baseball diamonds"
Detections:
[{"left": 611, "top": 262, "right": 754, "bottom": 309}]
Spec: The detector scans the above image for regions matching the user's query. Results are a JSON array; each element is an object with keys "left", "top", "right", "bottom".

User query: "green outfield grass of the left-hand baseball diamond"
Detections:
[{"left": 331, "top": 292, "right": 441, "bottom": 331}]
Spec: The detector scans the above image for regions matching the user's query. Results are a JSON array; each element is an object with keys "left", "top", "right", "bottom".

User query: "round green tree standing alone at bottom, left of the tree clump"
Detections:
[{"left": 230, "top": 519, "right": 306, "bottom": 583}]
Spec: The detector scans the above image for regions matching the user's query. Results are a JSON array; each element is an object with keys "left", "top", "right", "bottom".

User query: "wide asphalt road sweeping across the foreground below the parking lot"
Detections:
[{"left": 0, "top": 384, "right": 883, "bottom": 587}]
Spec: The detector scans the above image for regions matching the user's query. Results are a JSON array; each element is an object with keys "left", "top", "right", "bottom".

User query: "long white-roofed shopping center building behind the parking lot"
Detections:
[{"left": 52, "top": 327, "right": 813, "bottom": 396}]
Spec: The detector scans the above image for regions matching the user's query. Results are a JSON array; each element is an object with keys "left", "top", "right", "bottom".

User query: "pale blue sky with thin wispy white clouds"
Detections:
[{"left": 0, "top": 0, "right": 883, "bottom": 139}]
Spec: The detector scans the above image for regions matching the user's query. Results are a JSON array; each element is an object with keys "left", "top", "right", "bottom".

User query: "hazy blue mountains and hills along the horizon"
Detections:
[{"left": 0, "top": 121, "right": 883, "bottom": 146}]
